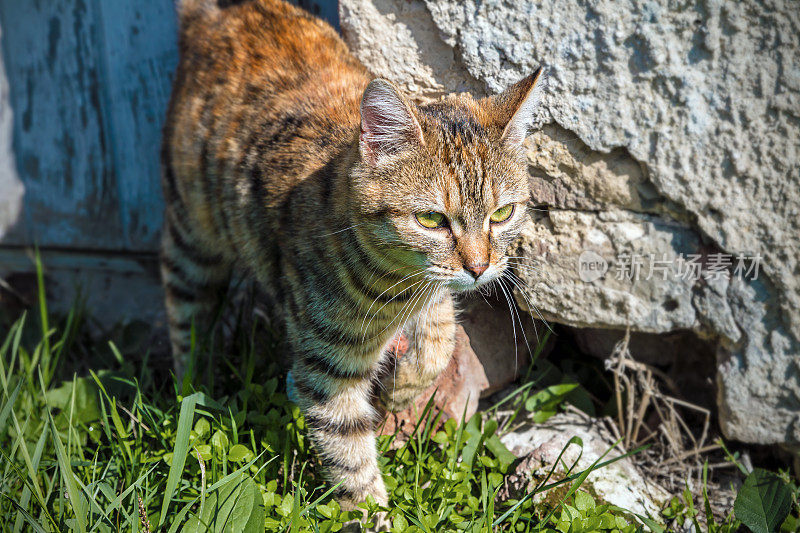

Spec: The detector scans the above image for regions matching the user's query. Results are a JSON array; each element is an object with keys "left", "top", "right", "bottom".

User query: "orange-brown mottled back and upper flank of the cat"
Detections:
[{"left": 162, "top": 0, "right": 369, "bottom": 251}]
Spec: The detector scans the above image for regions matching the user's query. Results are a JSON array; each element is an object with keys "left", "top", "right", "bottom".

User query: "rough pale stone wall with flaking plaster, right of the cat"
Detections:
[{"left": 340, "top": 0, "right": 800, "bottom": 446}]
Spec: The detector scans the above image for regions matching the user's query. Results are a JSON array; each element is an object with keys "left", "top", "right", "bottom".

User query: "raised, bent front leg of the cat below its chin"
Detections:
[{"left": 381, "top": 293, "right": 456, "bottom": 412}]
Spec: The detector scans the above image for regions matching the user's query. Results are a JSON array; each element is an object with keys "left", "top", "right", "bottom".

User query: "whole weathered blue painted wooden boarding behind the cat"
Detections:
[{"left": 0, "top": 0, "right": 338, "bottom": 251}]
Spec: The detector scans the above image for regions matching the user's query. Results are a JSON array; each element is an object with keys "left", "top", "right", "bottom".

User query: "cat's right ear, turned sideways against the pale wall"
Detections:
[{"left": 491, "top": 67, "right": 545, "bottom": 148}]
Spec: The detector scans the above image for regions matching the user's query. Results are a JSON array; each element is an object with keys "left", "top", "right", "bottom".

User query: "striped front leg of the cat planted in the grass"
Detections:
[{"left": 292, "top": 358, "right": 387, "bottom": 510}]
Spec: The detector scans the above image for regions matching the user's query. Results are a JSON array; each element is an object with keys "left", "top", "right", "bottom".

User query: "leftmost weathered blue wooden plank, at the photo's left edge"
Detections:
[{"left": 0, "top": 0, "right": 122, "bottom": 247}]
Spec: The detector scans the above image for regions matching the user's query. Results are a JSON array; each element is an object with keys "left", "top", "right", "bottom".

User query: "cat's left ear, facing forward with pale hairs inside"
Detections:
[{"left": 359, "top": 79, "right": 425, "bottom": 165}]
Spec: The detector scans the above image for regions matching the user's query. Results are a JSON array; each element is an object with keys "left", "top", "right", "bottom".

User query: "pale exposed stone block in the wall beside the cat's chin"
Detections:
[{"left": 514, "top": 209, "right": 697, "bottom": 333}]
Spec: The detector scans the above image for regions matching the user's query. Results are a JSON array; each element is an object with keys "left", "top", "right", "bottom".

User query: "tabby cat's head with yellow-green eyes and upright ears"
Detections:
[{"left": 353, "top": 68, "right": 542, "bottom": 292}]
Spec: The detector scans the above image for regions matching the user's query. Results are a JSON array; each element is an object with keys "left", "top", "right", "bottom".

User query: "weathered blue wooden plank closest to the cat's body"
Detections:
[{"left": 93, "top": 0, "right": 177, "bottom": 250}]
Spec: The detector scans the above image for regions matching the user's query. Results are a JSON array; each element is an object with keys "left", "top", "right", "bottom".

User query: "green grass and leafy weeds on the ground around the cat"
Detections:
[{"left": 0, "top": 260, "right": 796, "bottom": 533}]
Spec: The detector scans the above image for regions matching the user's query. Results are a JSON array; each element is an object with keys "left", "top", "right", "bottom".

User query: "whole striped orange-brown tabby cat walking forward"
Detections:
[{"left": 161, "top": 0, "right": 541, "bottom": 508}]
